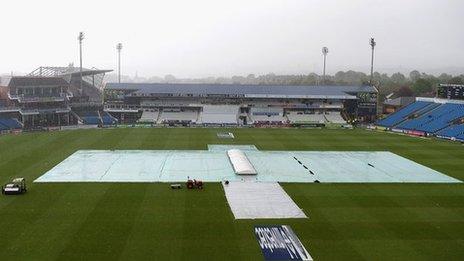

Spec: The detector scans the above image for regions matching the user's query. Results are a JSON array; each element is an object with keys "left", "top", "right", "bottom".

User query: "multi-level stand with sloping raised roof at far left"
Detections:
[{"left": 0, "top": 64, "right": 115, "bottom": 130}]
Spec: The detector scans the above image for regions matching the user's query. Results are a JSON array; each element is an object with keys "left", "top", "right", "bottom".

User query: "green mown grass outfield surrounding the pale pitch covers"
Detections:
[{"left": 0, "top": 128, "right": 464, "bottom": 260}]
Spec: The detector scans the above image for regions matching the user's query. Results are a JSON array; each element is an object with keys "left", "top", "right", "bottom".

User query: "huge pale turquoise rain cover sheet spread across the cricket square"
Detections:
[{"left": 35, "top": 145, "right": 461, "bottom": 183}]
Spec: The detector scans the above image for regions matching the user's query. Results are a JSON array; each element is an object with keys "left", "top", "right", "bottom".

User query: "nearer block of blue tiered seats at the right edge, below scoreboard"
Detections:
[{"left": 398, "top": 103, "right": 464, "bottom": 133}]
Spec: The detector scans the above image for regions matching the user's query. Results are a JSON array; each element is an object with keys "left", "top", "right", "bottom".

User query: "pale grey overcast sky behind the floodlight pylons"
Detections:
[{"left": 0, "top": 0, "right": 464, "bottom": 77}]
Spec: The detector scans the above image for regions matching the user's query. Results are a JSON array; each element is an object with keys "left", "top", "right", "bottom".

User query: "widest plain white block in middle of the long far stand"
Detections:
[{"left": 200, "top": 105, "right": 239, "bottom": 124}]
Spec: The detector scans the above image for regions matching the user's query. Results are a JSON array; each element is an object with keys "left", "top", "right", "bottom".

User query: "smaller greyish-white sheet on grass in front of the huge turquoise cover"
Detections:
[{"left": 223, "top": 181, "right": 307, "bottom": 219}]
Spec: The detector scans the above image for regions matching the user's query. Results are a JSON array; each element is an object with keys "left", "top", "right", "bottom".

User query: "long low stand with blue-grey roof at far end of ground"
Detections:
[{"left": 104, "top": 83, "right": 378, "bottom": 125}]
